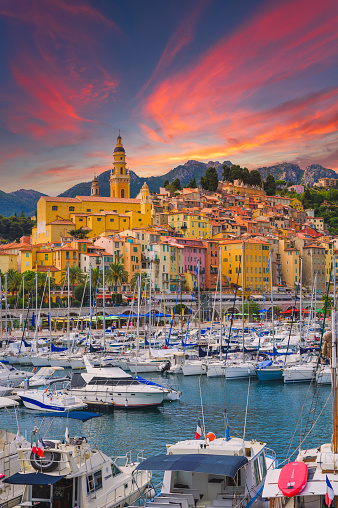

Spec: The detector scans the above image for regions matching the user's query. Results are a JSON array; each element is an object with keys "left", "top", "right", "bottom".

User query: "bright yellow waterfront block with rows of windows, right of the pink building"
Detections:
[{"left": 220, "top": 238, "right": 270, "bottom": 291}]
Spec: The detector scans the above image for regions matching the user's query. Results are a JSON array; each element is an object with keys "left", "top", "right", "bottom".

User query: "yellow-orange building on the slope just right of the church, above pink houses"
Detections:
[{"left": 168, "top": 212, "right": 212, "bottom": 238}]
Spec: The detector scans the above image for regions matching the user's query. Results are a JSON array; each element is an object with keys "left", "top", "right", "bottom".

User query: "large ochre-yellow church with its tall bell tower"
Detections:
[{"left": 32, "top": 135, "right": 151, "bottom": 245}]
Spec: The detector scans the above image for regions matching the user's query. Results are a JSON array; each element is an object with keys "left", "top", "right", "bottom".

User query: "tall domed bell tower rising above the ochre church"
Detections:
[{"left": 110, "top": 133, "right": 130, "bottom": 199}]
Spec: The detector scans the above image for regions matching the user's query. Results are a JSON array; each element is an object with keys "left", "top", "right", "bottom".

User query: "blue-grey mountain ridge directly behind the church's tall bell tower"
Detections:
[{"left": 60, "top": 160, "right": 232, "bottom": 198}]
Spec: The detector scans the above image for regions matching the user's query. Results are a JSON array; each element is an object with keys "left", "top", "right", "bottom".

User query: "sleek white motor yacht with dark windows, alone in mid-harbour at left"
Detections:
[{"left": 70, "top": 355, "right": 168, "bottom": 408}]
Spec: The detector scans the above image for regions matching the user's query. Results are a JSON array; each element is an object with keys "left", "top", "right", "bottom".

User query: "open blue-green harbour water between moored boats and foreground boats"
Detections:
[{"left": 1, "top": 374, "right": 332, "bottom": 461}]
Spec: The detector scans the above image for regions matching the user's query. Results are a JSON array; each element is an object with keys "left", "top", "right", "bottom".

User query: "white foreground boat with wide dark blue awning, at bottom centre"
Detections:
[{"left": 136, "top": 420, "right": 276, "bottom": 508}]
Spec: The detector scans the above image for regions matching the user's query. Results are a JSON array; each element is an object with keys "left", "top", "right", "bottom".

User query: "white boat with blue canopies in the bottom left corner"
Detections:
[{"left": 4, "top": 412, "right": 151, "bottom": 508}]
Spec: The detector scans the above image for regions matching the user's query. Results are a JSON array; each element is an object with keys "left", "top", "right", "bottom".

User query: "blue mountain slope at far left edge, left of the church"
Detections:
[{"left": 0, "top": 189, "right": 46, "bottom": 217}]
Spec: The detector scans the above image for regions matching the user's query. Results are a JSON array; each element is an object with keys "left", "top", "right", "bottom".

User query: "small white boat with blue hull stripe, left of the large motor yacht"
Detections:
[{"left": 17, "top": 387, "right": 87, "bottom": 413}]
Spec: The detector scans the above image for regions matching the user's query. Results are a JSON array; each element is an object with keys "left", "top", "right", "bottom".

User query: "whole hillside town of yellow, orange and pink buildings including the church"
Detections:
[{"left": 0, "top": 135, "right": 338, "bottom": 303}]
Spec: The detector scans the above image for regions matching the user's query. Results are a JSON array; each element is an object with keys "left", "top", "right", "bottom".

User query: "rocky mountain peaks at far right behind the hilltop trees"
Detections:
[{"left": 257, "top": 162, "right": 338, "bottom": 186}]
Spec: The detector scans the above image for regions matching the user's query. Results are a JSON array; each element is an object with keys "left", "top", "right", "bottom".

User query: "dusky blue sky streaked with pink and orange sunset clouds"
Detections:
[{"left": 0, "top": 0, "right": 338, "bottom": 195}]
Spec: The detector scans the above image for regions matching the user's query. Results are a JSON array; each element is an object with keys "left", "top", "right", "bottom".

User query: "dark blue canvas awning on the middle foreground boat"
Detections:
[{"left": 136, "top": 453, "right": 248, "bottom": 478}]
